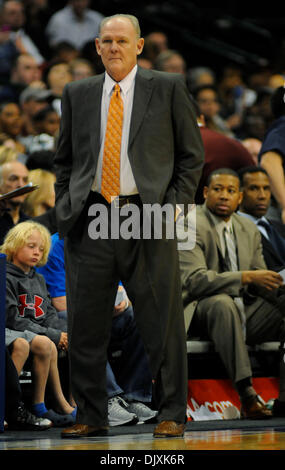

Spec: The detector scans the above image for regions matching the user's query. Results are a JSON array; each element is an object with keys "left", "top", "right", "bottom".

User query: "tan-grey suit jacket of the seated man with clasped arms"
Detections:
[{"left": 178, "top": 205, "right": 267, "bottom": 331}]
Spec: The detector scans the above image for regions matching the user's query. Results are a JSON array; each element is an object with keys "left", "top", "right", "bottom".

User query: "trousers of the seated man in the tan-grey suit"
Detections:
[{"left": 188, "top": 294, "right": 285, "bottom": 385}]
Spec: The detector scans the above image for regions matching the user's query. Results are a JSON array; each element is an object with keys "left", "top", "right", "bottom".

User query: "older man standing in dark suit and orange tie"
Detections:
[{"left": 55, "top": 15, "right": 203, "bottom": 437}]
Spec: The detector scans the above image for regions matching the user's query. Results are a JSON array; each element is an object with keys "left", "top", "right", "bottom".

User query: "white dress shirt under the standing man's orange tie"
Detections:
[{"left": 91, "top": 66, "right": 138, "bottom": 196}]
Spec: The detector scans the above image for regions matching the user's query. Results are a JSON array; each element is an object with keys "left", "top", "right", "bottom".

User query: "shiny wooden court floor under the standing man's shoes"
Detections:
[{"left": 0, "top": 419, "right": 285, "bottom": 454}]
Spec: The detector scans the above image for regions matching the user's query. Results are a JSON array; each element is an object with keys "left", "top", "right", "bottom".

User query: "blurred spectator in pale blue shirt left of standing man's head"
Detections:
[{"left": 45, "top": 0, "right": 103, "bottom": 50}]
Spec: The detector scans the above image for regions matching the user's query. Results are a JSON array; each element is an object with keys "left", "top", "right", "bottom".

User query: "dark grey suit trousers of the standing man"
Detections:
[{"left": 65, "top": 191, "right": 187, "bottom": 426}]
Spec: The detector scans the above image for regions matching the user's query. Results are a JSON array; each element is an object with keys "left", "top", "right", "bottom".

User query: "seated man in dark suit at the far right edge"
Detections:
[{"left": 238, "top": 167, "right": 285, "bottom": 272}]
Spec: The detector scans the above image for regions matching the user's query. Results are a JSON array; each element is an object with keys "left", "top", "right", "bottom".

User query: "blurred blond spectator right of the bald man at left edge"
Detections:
[{"left": 23, "top": 168, "right": 56, "bottom": 218}]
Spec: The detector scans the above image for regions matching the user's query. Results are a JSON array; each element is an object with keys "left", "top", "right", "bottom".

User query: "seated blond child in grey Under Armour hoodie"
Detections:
[{"left": 1, "top": 221, "right": 76, "bottom": 427}]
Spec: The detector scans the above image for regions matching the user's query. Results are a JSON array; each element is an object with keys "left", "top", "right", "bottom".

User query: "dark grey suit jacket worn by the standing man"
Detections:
[{"left": 55, "top": 67, "right": 204, "bottom": 235}]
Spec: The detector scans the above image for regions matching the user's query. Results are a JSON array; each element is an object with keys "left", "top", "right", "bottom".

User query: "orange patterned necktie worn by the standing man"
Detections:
[{"left": 101, "top": 84, "right": 124, "bottom": 203}]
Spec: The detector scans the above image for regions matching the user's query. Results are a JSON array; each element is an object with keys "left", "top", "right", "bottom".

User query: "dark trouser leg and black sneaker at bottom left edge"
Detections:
[{"left": 5, "top": 343, "right": 52, "bottom": 431}]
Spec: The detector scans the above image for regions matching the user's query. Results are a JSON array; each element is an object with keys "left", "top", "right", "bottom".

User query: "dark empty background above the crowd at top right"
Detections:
[{"left": 81, "top": 0, "right": 285, "bottom": 79}]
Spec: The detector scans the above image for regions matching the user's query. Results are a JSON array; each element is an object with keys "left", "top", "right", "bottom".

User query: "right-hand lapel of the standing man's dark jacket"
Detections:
[{"left": 129, "top": 67, "right": 153, "bottom": 151}]
